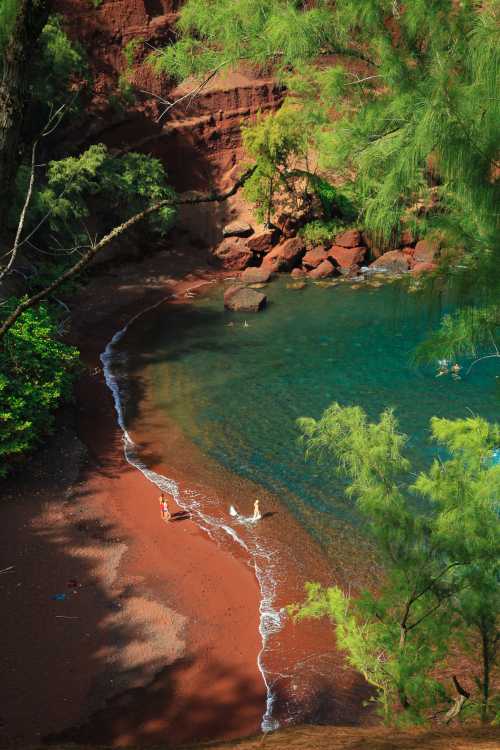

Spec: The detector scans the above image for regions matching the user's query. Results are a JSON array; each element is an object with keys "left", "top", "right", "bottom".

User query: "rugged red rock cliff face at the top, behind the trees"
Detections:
[{"left": 56, "top": 0, "right": 282, "bottom": 190}]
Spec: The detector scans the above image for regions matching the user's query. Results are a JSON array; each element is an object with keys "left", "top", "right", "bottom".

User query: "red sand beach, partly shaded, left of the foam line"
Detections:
[{"left": 0, "top": 253, "right": 266, "bottom": 746}]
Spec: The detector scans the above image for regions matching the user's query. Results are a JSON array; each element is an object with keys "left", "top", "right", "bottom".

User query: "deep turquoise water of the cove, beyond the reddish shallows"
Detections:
[{"left": 131, "top": 280, "right": 500, "bottom": 536}]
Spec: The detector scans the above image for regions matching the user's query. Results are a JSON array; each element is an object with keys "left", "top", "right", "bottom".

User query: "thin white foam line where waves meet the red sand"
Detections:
[{"left": 100, "top": 295, "right": 282, "bottom": 732}]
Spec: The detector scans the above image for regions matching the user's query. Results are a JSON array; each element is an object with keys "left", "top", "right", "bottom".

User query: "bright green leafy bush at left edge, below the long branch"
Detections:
[{"left": 0, "top": 299, "right": 78, "bottom": 476}]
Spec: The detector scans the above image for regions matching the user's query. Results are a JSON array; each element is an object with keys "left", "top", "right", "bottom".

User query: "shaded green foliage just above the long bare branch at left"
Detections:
[{"left": 14, "top": 144, "right": 175, "bottom": 244}]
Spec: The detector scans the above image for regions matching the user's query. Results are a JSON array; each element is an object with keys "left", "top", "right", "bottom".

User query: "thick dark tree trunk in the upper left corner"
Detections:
[{"left": 0, "top": 0, "right": 51, "bottom": 232}]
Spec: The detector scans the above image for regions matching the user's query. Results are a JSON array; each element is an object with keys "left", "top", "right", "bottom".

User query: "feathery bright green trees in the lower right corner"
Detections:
[{"left": 291, "top": 404, "right": 500, "bottom": 723}]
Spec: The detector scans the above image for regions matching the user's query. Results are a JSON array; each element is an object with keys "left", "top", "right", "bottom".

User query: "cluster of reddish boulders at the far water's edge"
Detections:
[{"left": 212, "top": 222, "right": 439, "bottom": 311}]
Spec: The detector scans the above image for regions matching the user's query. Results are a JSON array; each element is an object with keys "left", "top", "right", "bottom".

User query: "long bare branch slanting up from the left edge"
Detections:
[{"left": 0, "top": 167, "right": 256, "bottom": 342}]
